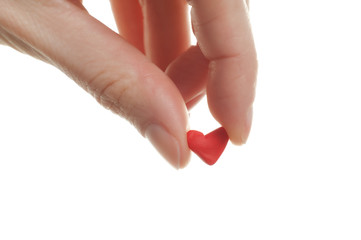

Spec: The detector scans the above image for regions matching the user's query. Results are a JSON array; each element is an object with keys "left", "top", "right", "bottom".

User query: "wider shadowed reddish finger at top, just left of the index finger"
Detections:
[{"left": 141, "top": 0, "right": 190, "bottom": 70}]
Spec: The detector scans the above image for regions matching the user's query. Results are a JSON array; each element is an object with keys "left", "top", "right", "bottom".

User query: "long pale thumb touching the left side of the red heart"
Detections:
[{"left": 0, "top": 0, "right": 190, "bottom": 167}]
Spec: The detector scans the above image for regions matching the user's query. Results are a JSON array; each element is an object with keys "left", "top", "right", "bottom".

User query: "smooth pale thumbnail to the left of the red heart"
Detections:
[{"left": 145, "top": 124, "right": 180, "bottom": 169}]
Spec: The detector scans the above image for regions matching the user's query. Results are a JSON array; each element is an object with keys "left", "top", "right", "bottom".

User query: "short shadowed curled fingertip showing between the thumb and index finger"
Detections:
[{"left": 166, "top": 46, "right": 209, "bottom": 109}]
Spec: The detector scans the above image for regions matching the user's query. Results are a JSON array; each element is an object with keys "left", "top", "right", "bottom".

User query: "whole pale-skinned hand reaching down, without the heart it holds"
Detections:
[{"left": 0, "top": 0, "right": 257, "bottom": 168}]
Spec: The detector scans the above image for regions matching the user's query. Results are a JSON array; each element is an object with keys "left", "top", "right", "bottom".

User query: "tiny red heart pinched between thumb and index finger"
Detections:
[{"left": 187, "top": 127, "right": 229, "bottom": 165}]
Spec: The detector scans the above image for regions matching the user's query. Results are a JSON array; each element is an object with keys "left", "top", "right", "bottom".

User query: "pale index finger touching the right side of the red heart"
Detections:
[{"left": 189, "top": 0, "right": 257, "bottom": 144}]
